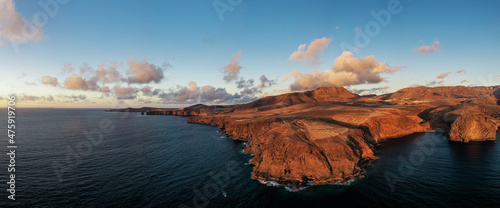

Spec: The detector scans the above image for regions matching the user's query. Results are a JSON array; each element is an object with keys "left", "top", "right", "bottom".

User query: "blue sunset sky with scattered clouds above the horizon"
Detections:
[{"left": 0, "top": 0, "right": 500, "bottom": 108}]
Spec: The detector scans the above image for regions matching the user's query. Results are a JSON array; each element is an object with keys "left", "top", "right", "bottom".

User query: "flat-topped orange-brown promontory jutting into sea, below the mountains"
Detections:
[{"left": 187, "top": 103, "right": 428, "bottom": 188}]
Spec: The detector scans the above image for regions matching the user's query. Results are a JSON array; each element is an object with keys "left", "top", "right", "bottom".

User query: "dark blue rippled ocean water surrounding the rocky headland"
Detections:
[{"left": 0, "top": 109, "right": 500, "bottom": 207}]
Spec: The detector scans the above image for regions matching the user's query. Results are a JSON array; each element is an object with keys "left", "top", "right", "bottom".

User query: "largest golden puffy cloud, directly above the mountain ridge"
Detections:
[{"left": 282, "top": 51, "right": 404, "bottom": 91}]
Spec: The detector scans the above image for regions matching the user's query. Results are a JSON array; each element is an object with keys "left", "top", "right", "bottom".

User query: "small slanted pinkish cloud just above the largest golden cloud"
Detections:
[{"left": 290, "top": 37, "right": 332, "bottom": 65}]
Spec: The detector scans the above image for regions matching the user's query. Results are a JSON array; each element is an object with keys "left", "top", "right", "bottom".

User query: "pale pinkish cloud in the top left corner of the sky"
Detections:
[{"left": 0, "top": 0, "right": 43, "bottom": 45}]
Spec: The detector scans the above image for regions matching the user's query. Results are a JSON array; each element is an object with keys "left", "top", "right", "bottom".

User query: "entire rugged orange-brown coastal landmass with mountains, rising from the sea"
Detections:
[{"left": 110, "top": 86, "right": 500, "bottom": 188}]
